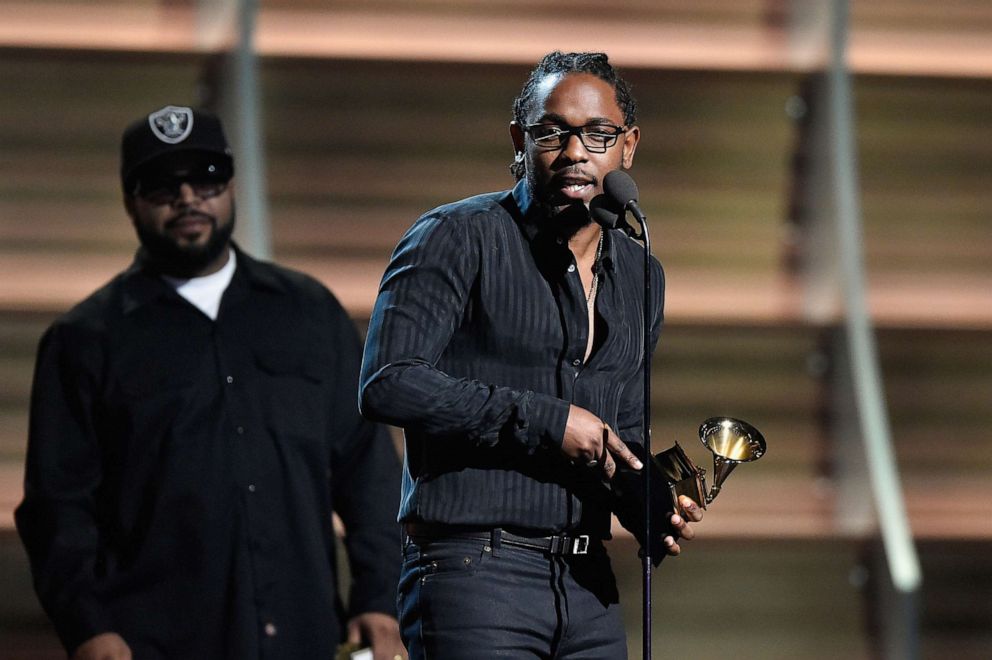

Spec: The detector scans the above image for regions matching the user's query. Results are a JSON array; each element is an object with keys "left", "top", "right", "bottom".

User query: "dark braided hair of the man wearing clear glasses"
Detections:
[{"left": 510, "top": 50, "right": 637, "bottom": 180}]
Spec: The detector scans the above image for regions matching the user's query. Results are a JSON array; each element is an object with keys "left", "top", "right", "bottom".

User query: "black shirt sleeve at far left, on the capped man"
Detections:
[{"left": 15, "top": 326, "right": 113, "bottom": 653}]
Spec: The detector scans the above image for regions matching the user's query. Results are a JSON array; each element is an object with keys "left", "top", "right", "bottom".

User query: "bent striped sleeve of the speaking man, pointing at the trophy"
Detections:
[{"left": 361, "top": 212, "right": 569, "bottom": 449}]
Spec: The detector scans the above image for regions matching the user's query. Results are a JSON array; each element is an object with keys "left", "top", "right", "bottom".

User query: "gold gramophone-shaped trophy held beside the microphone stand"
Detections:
[{"left": 654, "top": 417, "right": 765, "bottom": 511}]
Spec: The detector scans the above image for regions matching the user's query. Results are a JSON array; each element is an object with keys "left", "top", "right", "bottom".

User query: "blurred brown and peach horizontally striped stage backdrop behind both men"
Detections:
[{"left": 0, "top": 0, "right": 992, "bottom": 660}]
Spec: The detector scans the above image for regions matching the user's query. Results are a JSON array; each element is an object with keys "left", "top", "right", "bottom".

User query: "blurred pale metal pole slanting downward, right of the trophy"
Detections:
[{"left": 794, "top": 0, "right": 922, "bottom": 660}]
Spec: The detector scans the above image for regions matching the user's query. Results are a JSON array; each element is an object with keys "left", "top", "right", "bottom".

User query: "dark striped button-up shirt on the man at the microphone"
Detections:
[{"left": 362, "top": 181, "right": 664, "bottom": 538}]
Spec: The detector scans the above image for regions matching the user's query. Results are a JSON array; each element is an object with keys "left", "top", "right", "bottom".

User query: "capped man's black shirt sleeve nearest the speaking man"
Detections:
[{"left": 331, "top": 303, "right": 401, "bottom": 617}]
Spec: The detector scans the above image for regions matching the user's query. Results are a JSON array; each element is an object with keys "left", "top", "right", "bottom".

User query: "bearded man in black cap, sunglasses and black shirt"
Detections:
[{"left": 15, "top": 106, "right": 405, "bottom": 660}]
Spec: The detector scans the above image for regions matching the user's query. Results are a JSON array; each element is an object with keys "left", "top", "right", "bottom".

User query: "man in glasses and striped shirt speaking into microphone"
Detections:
[{"left": 361, "top": 52, "right": 702, "bottom": 660}]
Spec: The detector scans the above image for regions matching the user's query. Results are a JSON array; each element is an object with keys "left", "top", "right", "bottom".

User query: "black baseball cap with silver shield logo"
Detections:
[{"left": 121, "top": 105, "right": 234, "bottom": 193}]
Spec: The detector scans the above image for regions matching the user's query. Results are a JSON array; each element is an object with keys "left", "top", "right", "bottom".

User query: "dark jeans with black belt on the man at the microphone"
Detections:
[{"left": 398, "top": 537, "right": 627, "bottom": 660}]
